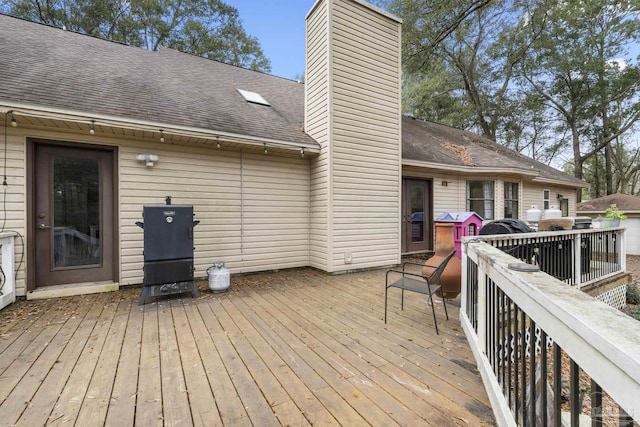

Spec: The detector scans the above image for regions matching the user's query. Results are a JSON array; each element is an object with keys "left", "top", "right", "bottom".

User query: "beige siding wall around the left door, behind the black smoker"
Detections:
[{"left": 6, "top": 127, "right": 310, "bottom": 295}]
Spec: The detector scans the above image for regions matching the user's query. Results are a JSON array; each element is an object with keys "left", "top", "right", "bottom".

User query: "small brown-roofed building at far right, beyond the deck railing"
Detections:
[{"left": 577, "top": 193, "right": 640, "bottom": 255}]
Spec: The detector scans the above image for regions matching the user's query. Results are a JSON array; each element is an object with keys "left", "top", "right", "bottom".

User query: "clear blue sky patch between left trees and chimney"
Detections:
[{"left": 226, "top": 0, "right": 316, "bottom": 79}]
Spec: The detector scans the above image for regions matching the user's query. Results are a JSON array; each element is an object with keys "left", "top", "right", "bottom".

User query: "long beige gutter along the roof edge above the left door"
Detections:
[{"left": 0, "top": 101, "right": 320, "bottom": 153}]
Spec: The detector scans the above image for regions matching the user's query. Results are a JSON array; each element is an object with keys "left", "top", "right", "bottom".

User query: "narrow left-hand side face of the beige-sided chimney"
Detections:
[{"left": 305, "top": 1, "right": 331, "bottom": 270}]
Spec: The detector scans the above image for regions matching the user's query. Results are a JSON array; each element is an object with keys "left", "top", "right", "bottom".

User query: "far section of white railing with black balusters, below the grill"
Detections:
[{"left": 477, "top": 227, "right": 626, "bottom": 288}]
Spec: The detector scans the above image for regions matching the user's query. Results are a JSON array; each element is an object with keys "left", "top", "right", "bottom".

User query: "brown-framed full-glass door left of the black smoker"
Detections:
[{"left": 32, "top": 144, "right": 114, "bottom": 287}]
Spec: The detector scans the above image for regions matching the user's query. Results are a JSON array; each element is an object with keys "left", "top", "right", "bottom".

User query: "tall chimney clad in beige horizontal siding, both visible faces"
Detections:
[{"left": 305, "top": 0, "right": 401, "bottom": 272}]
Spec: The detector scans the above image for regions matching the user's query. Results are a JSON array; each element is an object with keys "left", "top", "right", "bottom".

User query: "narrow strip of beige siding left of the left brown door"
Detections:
[{"left": 0, "top": 125, "right": 27, "bottom": 295}]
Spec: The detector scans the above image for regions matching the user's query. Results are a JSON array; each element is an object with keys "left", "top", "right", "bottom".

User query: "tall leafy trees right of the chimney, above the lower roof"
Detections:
[{"left": 384, "top": 0, "right": 640, "bottom": 184}]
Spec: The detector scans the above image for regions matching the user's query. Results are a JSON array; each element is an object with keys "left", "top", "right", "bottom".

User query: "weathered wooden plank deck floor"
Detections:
[{"left": 0, "top": 269, "right": 494, "bottom": 427}]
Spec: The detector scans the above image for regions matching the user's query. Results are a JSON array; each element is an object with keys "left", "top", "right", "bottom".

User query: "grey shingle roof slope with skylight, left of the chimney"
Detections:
[{"left": 0, "top": 15, "right": 315, "bottom": 144}]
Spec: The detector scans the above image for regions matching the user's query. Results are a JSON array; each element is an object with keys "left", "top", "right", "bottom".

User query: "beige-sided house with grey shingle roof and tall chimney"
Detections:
[{"left": 0, "top": 0, "right": 586, "bottom": 296}]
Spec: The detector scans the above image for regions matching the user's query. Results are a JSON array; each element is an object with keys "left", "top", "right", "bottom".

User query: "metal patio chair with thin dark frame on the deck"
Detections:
[{"left": 384, "top": 250, "right": 456, "bottom": 335}]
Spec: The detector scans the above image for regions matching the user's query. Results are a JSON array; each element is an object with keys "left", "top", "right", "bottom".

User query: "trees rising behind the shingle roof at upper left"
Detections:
[{"left": 0, "top": 0, "right": 271, "bottom": 71}]
